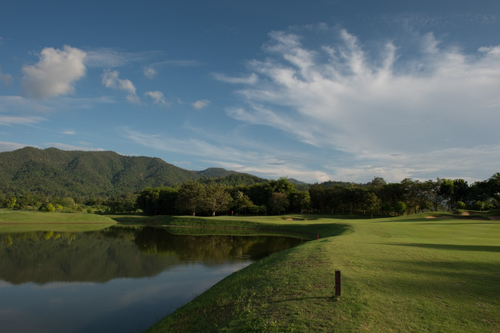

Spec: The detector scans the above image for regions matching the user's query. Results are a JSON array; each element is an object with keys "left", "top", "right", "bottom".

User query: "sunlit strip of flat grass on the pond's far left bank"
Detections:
[{"left": 0, "top": 209, "right": 116, "bottom": 233}]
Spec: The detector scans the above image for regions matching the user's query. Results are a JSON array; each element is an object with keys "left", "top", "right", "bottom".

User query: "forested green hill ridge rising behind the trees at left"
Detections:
[{"left": 0, "top": 147, "right": 265, "bottom": 196}]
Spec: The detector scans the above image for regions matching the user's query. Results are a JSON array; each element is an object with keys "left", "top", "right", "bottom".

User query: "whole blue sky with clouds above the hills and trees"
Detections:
[{"left": 0, "top": 0, "right": 500, "bottom": 183}]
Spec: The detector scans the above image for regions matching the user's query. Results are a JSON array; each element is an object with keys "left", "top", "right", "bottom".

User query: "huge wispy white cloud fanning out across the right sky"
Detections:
[{"left": 222, "top": 30, "right": 500, "bottom": 180}]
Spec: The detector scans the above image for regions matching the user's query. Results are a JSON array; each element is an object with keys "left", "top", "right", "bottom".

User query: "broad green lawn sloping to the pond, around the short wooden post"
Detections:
[{"left": 149, "top": 215, "right": 500, "bottom": 332}]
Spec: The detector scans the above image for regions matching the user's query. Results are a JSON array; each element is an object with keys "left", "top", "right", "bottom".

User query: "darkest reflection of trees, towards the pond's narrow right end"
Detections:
[{"left": 135, "top": 228, "right": 301, "bottom": 264}]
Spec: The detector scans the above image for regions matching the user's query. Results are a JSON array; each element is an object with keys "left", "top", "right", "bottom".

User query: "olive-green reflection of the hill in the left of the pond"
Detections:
[{"left": 0, "top": 231, "right": 174, "bottom": 284}]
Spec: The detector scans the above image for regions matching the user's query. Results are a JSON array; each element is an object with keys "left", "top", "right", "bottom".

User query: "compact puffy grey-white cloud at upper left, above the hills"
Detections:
[{"left": 22, "top": 45, "right": 86, "bottom": 99}]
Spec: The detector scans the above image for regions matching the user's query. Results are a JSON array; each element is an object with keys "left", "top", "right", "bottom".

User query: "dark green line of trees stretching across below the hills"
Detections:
[{"left": 0, "top": 173, "right": 500, "bottom": 216}]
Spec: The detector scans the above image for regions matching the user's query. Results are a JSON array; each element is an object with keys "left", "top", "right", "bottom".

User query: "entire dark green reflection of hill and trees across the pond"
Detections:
[{"left": 0, "top": 227, "right": 300, "bottom": 284}]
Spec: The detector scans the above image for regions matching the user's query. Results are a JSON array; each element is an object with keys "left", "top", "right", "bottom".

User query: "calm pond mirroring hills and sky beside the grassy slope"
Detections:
[{"left": 0, "top": 227, "right": 302, "bottom": 333}]
